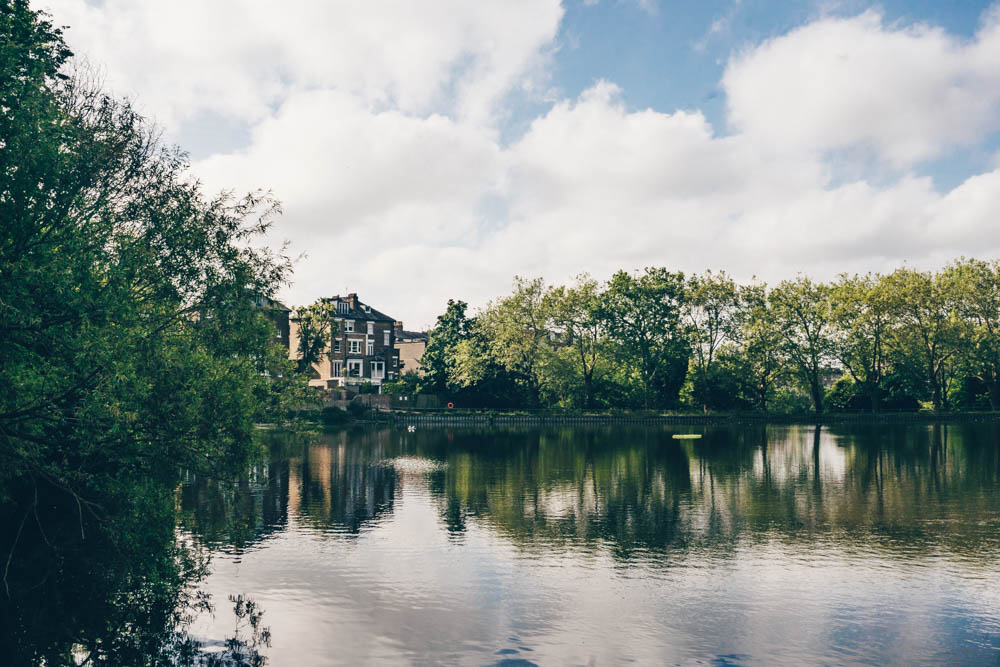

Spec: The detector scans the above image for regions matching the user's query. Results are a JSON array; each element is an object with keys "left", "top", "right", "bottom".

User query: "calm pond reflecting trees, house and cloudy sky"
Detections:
[{"left": 180, "top": 424, "right": 1000, "bottom": 665}]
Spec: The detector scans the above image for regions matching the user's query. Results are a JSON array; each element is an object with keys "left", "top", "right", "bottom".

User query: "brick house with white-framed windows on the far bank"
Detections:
[{"left": 289, "top": 294, "right": 399, "bottom": 392}]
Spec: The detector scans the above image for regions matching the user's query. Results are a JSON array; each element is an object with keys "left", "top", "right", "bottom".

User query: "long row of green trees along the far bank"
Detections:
[{"left": 395, "top": 258, "right": 1000, "bottom": 413}]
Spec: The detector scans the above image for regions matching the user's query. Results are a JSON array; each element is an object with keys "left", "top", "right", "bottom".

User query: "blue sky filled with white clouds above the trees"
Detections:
[{"left": 43, "top": 0, "right": 1000, "bottom": 329}]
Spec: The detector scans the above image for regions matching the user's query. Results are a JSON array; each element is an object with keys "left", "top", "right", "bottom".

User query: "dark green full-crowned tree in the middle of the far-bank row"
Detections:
[{"left": 601, "top": 267, "right": 689, "bottom": 408}]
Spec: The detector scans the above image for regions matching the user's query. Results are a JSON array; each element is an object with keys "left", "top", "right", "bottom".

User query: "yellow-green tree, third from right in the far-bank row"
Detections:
[{"left": 830, "top": 274, "right": 893, "bottom": 412}]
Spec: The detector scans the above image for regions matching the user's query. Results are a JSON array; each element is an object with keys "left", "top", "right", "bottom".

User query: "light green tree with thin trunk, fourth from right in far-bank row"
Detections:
[{"left": 770, "top": 276, "right": 832, "bottom": 414}]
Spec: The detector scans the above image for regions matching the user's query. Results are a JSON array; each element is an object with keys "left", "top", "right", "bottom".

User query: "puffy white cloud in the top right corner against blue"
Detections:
[{"left": 723, "top": 11, "right": 1000, "bottom": 167}]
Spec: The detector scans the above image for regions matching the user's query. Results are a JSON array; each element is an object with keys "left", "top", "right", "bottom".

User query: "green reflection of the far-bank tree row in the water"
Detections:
[{"left": 412, "top": 425, "right": 1000, "bottom": 556}]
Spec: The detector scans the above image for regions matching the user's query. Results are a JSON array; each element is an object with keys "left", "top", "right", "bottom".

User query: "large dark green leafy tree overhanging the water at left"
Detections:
[{"left": 0, "top": 0, "right": 292, "bottom": 664}]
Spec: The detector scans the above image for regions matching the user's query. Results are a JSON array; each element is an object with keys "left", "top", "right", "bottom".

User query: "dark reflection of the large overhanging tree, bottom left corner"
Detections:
[{"left": 0, "top": 483, "right": 270, "bottom": 666}]
